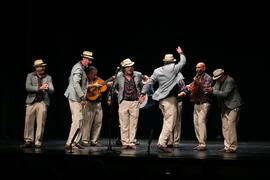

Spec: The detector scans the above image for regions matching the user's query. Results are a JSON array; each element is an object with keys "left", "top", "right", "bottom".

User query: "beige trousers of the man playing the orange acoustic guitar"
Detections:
[{"left": 82, "top": 101, "right": 103, "bottom": 144}]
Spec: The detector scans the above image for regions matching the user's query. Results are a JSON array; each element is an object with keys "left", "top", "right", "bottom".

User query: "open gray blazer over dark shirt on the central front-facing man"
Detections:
[{"left": 108, "top": 71, "right": 143, "bottom": 104}]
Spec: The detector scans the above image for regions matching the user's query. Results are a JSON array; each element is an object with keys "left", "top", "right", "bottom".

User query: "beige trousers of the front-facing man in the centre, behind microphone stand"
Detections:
[{"left": 118, "top": 100, "right": 140, "bottom": 145}]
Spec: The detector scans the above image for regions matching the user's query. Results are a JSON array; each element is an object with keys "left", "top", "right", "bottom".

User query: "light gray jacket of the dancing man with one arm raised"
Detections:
[{"left": 142, "top": 54, "right": 186, "bottom": 101}]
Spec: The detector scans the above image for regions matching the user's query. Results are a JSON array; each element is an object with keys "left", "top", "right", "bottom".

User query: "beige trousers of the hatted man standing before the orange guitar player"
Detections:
[{"left": 66, "top": 99, "right": 84, "bottom": 145}]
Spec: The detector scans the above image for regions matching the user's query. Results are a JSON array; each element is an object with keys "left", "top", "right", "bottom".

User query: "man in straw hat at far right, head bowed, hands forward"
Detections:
[{"left": 204, "top": 69, "right": 243, "bottom": 153}]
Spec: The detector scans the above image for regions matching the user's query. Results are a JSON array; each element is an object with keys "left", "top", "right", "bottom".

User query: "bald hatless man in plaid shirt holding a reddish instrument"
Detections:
[{"left": 186, "top": 62, "right": 213, "bottom": 151}]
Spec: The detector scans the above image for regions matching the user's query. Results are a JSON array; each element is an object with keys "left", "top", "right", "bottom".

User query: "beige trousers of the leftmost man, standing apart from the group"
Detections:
[{"left": 24, "top": 101, "right": 47, "bottom": 145}]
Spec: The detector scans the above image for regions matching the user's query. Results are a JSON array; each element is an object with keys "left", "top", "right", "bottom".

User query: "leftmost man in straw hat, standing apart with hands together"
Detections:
[{"left": 20, "top": 59, "right": 54, "bottom": 148}]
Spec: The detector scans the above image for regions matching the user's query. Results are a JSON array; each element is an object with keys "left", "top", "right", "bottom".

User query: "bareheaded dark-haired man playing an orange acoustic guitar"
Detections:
[{"left": 82, "top": 66, "right": 112, "bottom": 147}]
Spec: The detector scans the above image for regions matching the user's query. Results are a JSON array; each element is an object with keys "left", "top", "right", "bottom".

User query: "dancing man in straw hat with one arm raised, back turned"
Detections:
[{"left": 140, "top": 46, "right": 186, "bottom": 153}]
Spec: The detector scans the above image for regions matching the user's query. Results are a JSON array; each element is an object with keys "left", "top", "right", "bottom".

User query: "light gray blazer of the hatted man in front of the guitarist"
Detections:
[{"left": 64, "top": 62, "right": 88, "bottom": 102}]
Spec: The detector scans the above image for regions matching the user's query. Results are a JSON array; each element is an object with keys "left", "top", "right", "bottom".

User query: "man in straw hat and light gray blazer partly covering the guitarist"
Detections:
[{"left": 64, "top": 51, "right": 94, "bottom": 149}]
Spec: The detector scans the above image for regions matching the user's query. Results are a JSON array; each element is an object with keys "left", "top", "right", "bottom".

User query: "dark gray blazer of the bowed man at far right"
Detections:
[{"left": 213, "top": 75, "right": 243, "bottom": 109}]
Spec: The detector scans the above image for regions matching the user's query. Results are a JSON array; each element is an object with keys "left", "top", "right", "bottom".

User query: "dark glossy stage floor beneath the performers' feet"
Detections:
[{"left": 0, "top": 139, "right": 270, "bottom": 179}]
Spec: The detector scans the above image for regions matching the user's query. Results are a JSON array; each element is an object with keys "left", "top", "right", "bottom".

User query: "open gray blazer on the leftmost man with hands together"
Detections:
[{"left": 25, "top": 72, "right": 54, "bottom": 106}]
